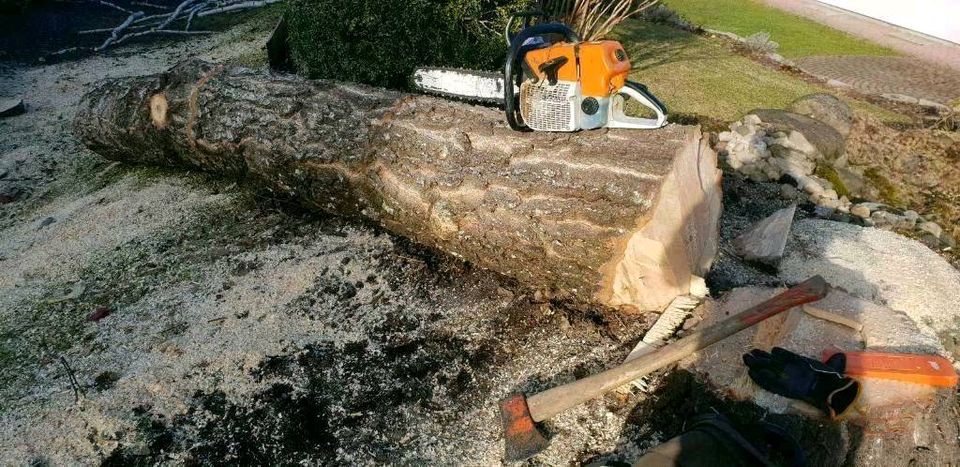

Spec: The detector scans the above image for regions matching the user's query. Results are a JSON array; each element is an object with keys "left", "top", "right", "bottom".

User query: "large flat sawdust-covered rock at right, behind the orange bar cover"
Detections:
[{"left": 779, "top": 219, "right": 960, "bottom": 344}]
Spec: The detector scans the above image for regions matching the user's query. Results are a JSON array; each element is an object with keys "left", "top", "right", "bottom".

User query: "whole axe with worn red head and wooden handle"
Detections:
[{"left": 500, "top": 276, "right": 829, "bottom": 461}]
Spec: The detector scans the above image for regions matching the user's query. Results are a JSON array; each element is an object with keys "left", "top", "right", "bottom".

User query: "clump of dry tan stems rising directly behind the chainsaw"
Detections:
[{"left": 543, "top": 0, "right": 659, "bottom": 41}]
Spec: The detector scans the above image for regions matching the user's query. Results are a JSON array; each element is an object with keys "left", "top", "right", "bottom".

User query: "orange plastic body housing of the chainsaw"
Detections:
[{"left": 524, "top": 41, "right": 630, "bottom": 98}]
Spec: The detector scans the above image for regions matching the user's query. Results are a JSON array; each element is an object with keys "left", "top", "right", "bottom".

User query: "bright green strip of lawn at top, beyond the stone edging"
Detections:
[{"left": 663, "top": 0, "right": 896, "bottom": 58}]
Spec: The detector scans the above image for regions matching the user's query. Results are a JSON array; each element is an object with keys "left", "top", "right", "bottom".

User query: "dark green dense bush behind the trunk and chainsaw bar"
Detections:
[{"left": 286, "top": 0, "right": 530, "bottom": 88}]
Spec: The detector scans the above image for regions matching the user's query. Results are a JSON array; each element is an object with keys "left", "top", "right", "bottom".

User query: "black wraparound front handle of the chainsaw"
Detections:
[{"left": 503, "top": 22, "right": 580, "bottom": 131}]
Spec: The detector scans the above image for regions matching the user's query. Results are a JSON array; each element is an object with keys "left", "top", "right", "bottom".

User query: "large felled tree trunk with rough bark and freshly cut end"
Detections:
[{"left": 75, "top": 62, "right": 720, "bottom": 310}]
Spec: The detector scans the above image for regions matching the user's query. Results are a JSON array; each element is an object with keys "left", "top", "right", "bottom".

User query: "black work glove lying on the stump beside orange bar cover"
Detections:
[{"left": 743, "top": 347, "right": 860, "bottom": 418}]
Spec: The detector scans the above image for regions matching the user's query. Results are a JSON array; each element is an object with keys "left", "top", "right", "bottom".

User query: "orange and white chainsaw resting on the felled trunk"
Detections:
[{"left": 413, "top": 12, "right": 667, "bottom": 132}]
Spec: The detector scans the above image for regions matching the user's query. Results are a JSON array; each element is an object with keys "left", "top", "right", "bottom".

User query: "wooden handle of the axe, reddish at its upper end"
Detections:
[{"left": 527, "top": 276, "right": 828, "bottom": 422}]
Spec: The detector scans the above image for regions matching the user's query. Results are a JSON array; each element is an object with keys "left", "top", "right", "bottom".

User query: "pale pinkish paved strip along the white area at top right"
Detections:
[{"left": 764, "top": 0, "right": 960, "bottom": 72}]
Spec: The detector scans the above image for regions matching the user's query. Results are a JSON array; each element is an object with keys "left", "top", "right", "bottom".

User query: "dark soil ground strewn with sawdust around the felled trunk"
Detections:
[{"left": 0, "top": 12, "right": 956, "bottom": 465}]
